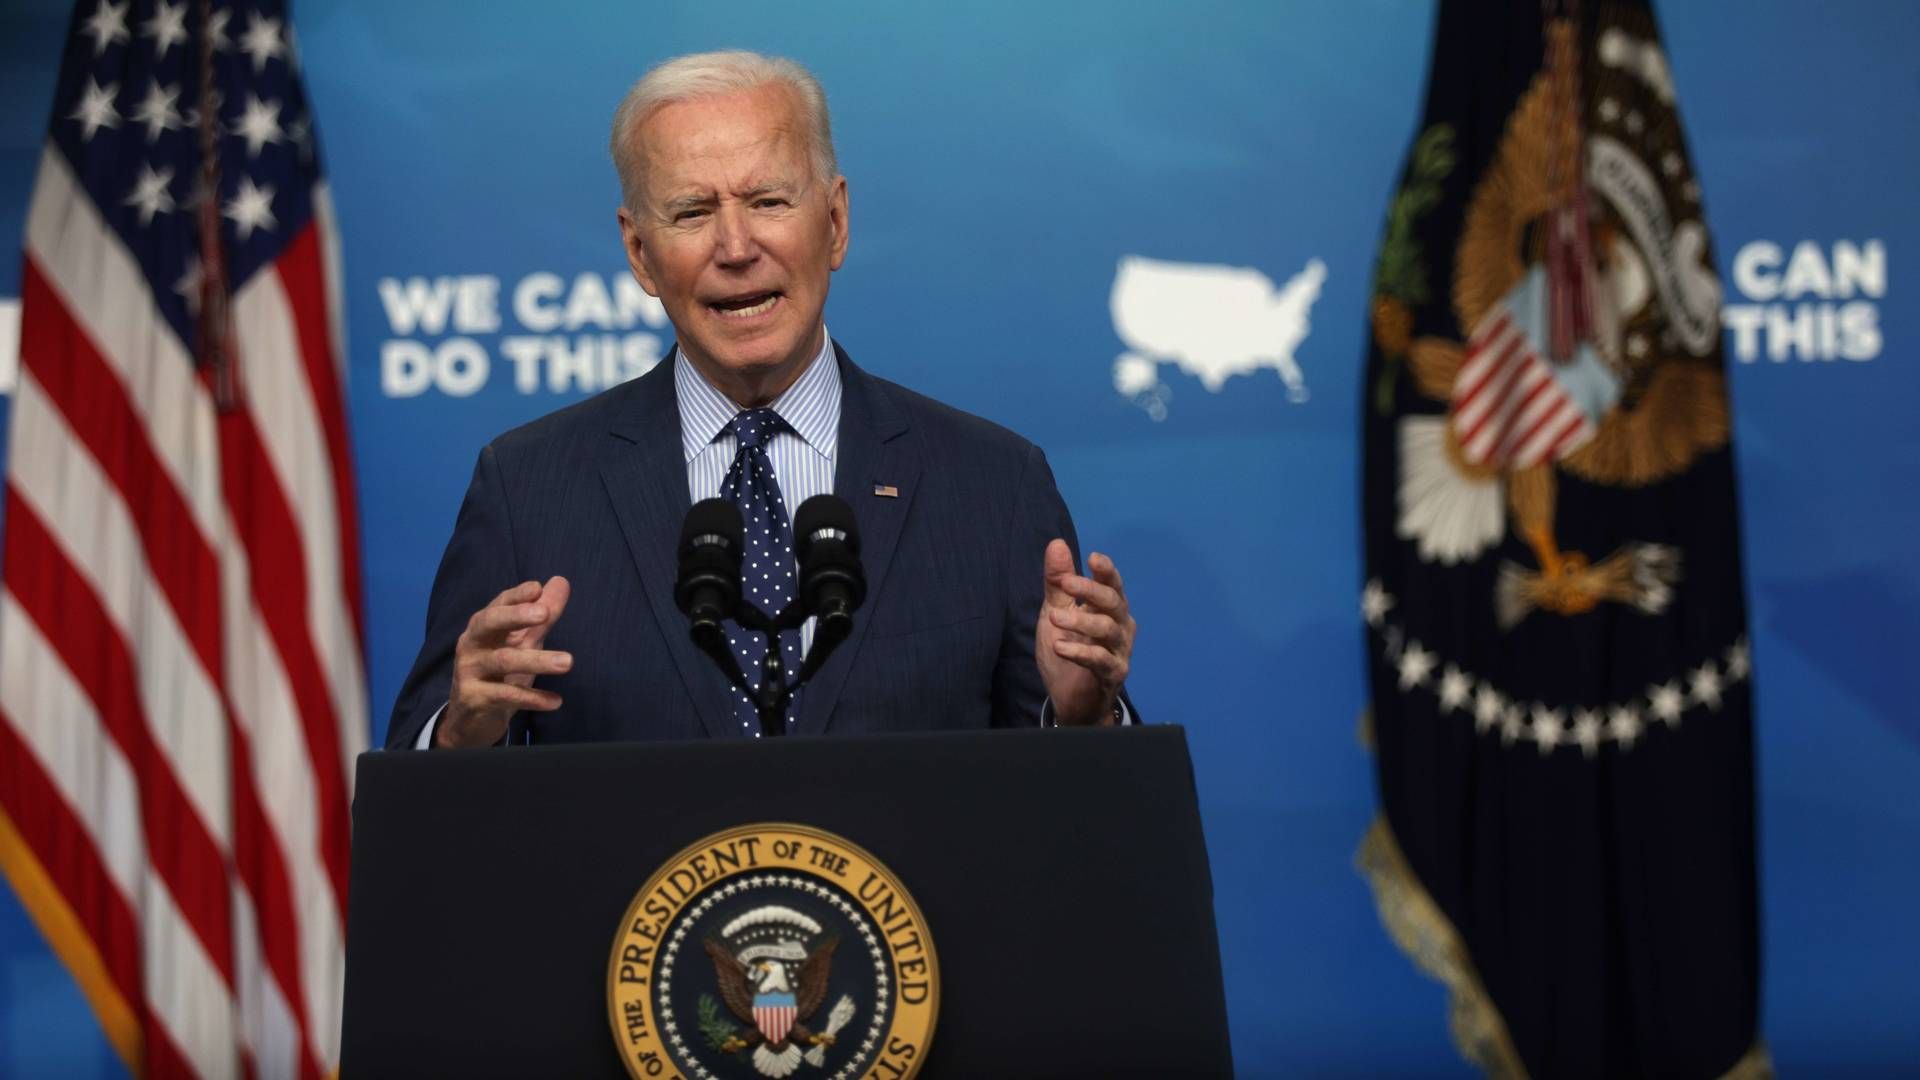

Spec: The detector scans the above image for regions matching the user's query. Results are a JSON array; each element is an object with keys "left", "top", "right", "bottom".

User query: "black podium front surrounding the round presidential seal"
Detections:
[{"left": 342, "top": 726, "right": 1233, "bottom": 1080}]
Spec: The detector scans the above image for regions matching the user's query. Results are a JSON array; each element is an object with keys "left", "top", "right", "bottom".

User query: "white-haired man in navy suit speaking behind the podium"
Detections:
[{"left": 388, "top": 52, "right": 1135, "bottom": 748}]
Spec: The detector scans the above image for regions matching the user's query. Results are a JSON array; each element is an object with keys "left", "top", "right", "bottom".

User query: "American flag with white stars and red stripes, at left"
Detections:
[{"left": 0, "top": 0, "right": 367, "bottom": 1076}]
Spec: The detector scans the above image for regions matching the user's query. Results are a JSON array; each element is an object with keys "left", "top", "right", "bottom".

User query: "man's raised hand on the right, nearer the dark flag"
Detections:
[{"left": 1033, "top": 540, "right": 1139, "bottom": 726}]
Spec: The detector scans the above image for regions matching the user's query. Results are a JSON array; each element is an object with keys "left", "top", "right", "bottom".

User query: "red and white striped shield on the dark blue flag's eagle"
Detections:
[{"left": 1452, "top": 306, "right": 1597, "bottom": 469}]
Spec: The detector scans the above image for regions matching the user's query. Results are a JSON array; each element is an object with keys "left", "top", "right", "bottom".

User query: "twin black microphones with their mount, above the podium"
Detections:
[{"left": 674, "top": 496, "right": 866, "bottom": 736}]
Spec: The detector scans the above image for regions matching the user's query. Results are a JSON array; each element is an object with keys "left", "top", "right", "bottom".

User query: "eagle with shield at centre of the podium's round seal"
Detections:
[{"left": 705, "top": 905, "right": 852, "bottom": 1078}]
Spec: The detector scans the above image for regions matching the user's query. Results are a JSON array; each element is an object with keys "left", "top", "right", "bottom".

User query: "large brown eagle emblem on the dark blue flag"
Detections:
[{"left": 1371, "top": 8, "right": 1730, "bottom": 628}]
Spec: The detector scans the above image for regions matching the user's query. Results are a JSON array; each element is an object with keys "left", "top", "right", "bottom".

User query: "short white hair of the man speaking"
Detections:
[{"left": 607, "top": 48, "right": 839, "bottom": 211}]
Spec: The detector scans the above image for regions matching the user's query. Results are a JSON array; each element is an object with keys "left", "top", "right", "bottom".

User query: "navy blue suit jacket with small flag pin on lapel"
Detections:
[{"left": 386, "top": 344, "right": 1079, "bottom": 748}]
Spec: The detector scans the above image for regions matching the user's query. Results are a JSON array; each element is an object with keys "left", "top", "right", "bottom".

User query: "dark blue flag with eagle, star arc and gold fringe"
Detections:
[{"left": 1359, "top": 0, "right": 1768, "bottom": 1078}]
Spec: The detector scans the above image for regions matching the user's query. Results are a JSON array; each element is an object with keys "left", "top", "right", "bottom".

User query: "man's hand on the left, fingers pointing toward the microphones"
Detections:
[{"left": 434, "top": 577, "right": 574, "bottom": 748}]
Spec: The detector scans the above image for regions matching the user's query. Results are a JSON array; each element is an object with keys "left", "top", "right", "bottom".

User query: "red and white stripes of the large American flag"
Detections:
[{"left": 0, "top": 146, "right": 367, "bottom": 1078}]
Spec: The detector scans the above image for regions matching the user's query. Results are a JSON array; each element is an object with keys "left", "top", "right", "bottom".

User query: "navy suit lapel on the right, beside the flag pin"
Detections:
[{"left": 791, "top": 342, "right": 922, "bottom": 734}]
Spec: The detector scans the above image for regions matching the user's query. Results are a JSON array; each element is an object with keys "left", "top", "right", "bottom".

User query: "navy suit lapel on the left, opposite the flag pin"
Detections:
[{"left": 599, "top": 349, "right": 739, "bottom": 738}]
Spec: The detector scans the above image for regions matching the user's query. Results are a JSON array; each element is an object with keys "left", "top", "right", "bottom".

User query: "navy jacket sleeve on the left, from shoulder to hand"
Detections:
[{"left": 386, "top": 446, "right": 520, "bottom": 749}]
